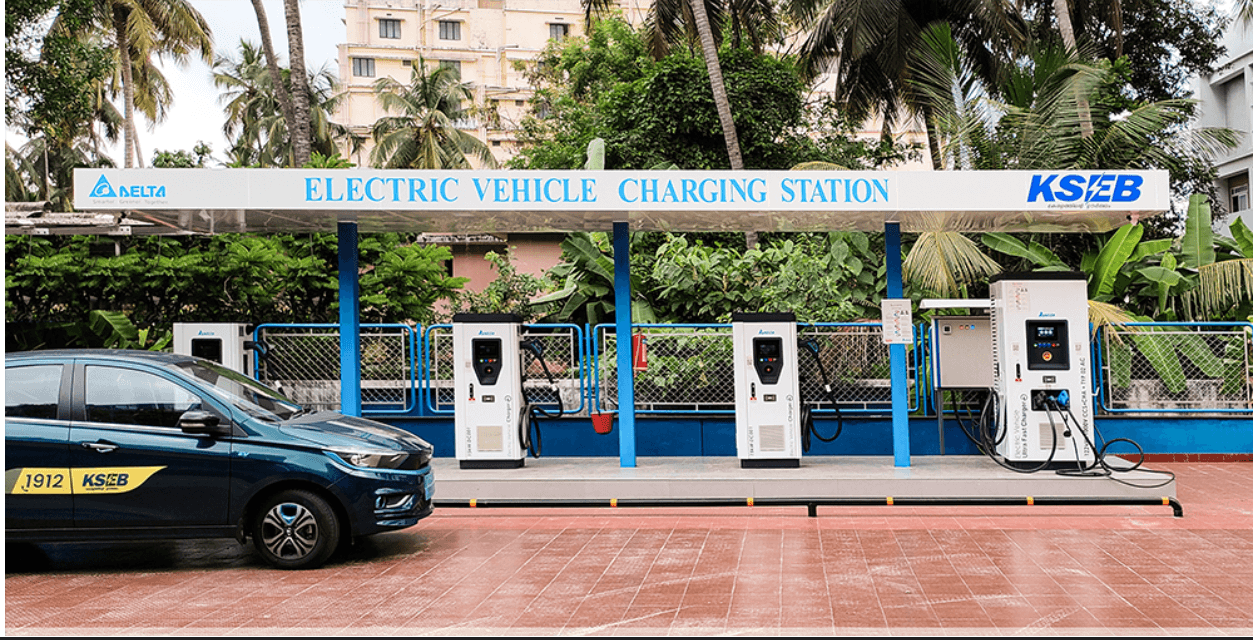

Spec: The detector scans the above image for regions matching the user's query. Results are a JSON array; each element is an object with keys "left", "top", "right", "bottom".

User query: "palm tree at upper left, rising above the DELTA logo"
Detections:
[{"left": 77, "top": 0, "right": 213, "bottom": 167}]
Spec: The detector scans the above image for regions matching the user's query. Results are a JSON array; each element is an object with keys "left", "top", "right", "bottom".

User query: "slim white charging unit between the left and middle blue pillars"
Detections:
[{"left": 452, "top": 313, "right": 529, "bottom": 468}]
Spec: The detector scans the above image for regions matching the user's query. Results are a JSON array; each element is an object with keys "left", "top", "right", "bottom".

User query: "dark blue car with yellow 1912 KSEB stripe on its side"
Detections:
[{"left": 4, "top": 349, "right": 435, "bottom": 569}]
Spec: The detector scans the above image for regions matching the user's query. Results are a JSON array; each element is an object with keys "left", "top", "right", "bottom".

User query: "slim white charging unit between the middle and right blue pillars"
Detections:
[{"left": 730, "top": 313, "right": 801, "bottom": 468}]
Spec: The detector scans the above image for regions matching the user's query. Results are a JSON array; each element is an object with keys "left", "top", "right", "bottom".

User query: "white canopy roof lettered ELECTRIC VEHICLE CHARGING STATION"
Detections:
[{"left": 74, "top": 169, "right": 1169, "bottom": 233}]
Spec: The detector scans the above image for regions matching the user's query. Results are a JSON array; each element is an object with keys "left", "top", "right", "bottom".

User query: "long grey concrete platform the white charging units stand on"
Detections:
[{"left": 434, "top": 456, "right": 1175, "bottom": 506}]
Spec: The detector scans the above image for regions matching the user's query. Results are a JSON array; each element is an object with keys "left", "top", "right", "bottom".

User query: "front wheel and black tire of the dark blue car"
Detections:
[{"left": 252, "top": 490, "right": 341, "bottom": 569}]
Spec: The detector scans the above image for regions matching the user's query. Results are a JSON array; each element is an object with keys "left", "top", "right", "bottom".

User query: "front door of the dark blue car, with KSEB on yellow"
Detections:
[{"left": 69, "top": 361, "right": 231, "bottom": 529}]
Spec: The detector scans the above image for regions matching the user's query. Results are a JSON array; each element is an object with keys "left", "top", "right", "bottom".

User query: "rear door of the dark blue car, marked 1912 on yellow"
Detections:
[{"left": 4, "top": 362, "right": 74, "bottom": 530}]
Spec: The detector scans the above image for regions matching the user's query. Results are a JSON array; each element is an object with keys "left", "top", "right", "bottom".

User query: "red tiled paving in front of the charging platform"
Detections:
[{"left": 5, "top": 462, "right": 1253, "bottom": 636}]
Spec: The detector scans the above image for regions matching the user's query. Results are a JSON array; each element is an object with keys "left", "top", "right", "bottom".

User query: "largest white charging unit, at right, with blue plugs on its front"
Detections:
[{"left": 989, "top": 272, "right": 1095, "bottom": 463}]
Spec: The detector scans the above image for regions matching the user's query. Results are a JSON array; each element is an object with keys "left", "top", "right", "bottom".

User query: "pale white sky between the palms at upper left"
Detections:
[{"left": 5, "top": 0, "right": 346, "bottom": 167}]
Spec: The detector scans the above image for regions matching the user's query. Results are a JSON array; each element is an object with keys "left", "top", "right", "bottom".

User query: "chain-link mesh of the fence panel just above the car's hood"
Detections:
[{"left": 257, "top": 324, "right": 417, "bottom": 412}]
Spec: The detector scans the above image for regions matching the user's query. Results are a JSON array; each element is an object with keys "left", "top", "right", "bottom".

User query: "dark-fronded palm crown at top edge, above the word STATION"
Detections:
[{"left": 791, "top": 0, "right": 1027, "bottom": 169}]
